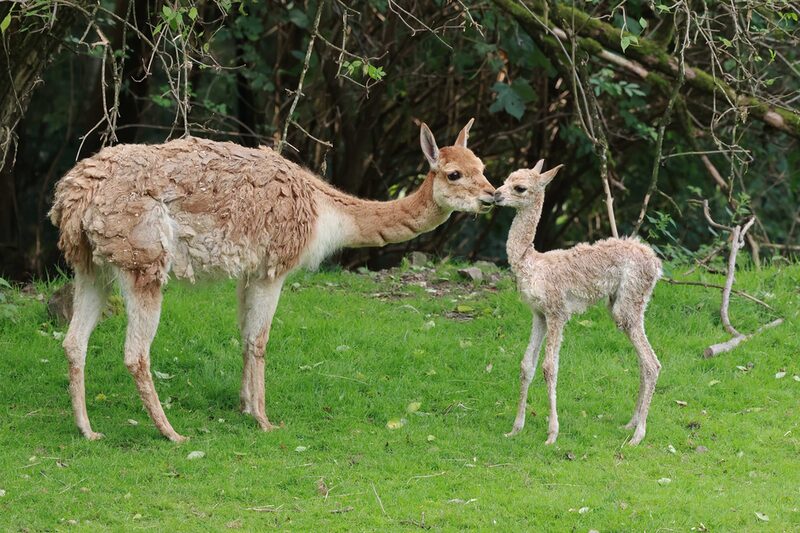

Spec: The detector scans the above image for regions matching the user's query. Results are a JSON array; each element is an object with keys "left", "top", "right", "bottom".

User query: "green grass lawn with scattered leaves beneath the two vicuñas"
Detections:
[{"left": 0, "top": 265, "right": 800, "bottom": 532}]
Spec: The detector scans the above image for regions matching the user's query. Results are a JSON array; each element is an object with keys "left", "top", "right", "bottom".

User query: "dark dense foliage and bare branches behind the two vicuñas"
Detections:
[{"left": 0, "top": 0, "right": 800, "bottom": 277}]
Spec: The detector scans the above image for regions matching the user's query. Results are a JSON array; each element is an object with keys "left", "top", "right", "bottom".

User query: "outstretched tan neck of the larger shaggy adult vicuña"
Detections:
[{"left": 324, "top": 174, "right": 450, "bottom": 248}]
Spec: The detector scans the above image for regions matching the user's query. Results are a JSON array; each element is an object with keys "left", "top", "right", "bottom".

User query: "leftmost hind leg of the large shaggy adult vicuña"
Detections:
[{"left": 63, "top": 270, "right": 108, "bottom": 440}]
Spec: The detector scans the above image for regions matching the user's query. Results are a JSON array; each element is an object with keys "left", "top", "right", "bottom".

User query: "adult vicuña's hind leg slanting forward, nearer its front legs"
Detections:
[{"left": 119, "top": 272, "right": 186, "bottom": 442}]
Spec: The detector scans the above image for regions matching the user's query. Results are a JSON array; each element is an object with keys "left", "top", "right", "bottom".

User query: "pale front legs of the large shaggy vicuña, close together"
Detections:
[{"left": 239, "top": 278, "right": 283, "bottom": 431}]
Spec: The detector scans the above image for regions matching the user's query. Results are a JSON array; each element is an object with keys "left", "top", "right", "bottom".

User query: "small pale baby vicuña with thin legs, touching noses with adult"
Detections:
[{"left": 495, "top": 160, "right": 661, "bottom": 445}]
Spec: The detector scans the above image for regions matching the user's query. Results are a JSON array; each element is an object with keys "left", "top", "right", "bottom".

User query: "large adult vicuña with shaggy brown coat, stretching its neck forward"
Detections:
[{"left": 50, "top": 120, "right": 494, "bottom": 441}]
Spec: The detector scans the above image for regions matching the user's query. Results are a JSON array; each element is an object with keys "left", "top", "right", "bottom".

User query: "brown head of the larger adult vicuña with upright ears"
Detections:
[{"left": 419, "top": 119, "right": 494, "bottom": 213}]
